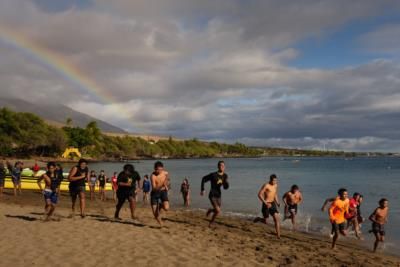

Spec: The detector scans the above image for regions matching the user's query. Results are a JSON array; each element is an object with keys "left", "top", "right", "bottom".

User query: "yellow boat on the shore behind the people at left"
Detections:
[{"left": 4, "top": 168, "right": 112, "bottom": 191}]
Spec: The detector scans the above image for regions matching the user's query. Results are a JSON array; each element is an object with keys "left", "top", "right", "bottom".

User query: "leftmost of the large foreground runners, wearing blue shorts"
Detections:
[{"left": 37, "top": 162, "right": 62, "bottom": 221}]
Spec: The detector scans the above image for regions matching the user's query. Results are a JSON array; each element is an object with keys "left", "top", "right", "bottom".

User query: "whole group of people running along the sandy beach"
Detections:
[{"left": 0, "top": 159, "right": 388, "bottom": 252}]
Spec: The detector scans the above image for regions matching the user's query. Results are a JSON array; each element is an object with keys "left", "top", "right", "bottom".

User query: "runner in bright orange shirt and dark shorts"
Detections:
[{"left": 329, "top": 188, "right": 349, "bottom": 249}]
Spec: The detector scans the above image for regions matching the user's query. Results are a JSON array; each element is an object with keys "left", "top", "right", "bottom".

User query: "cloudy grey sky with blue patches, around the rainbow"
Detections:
[{"left": 0, "top": 0, "right": 400, "bottom": 151}]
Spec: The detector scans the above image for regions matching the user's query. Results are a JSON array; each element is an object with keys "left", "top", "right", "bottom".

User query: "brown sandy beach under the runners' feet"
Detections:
[{"left": 0, "top": 191, "right": 400, "bottom": 266}]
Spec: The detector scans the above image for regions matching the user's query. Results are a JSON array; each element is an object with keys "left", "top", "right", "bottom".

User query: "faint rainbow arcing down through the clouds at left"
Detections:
[{"left": 0, "top": 25, "right": 133, "bottom": 128}]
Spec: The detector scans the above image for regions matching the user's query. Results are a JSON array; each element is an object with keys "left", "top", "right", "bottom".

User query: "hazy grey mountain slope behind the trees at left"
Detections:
[{"left": 0, "top": 98, "right": 126, "bottom": 133}]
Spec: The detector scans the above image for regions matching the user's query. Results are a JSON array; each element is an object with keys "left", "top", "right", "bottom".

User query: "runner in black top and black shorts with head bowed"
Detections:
[{"left": 114, "top": 164, "right": 140, "bottom": 220}]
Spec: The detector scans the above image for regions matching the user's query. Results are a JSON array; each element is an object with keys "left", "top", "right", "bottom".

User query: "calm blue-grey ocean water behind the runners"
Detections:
[{"left": 85, "top": 157, "right": 400, "bottom": 255}]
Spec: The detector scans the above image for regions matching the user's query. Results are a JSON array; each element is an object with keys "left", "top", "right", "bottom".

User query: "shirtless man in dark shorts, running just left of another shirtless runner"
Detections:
[{"left": 254, "top": 174, "right": 281, "bottom": 239}]
